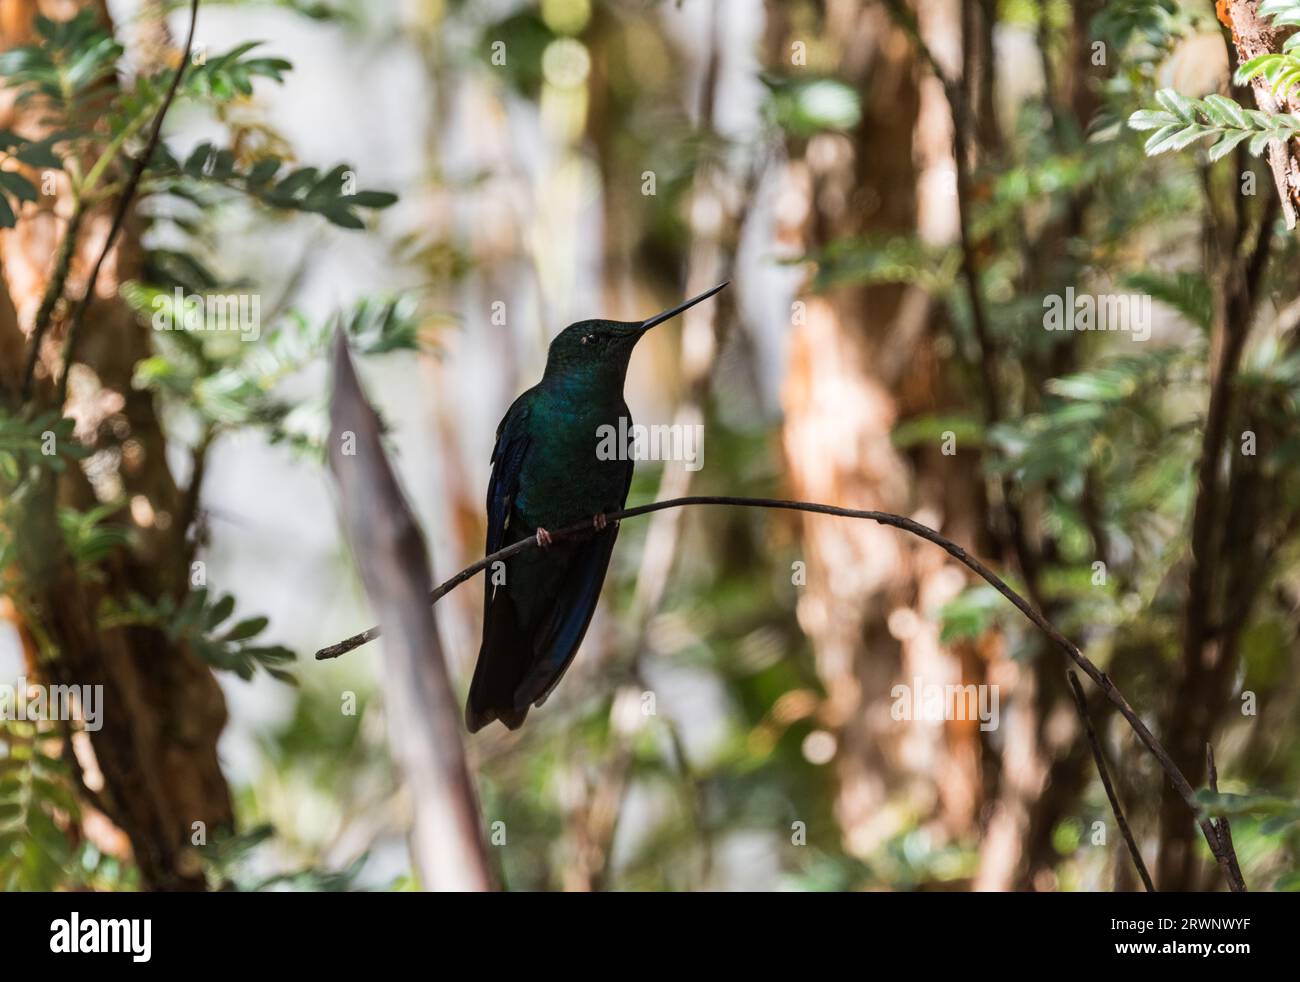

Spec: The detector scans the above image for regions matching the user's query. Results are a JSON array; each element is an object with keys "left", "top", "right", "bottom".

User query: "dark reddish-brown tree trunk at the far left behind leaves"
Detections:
[{"left": 0, "top": 0, "right": 233, "bottom": 890}]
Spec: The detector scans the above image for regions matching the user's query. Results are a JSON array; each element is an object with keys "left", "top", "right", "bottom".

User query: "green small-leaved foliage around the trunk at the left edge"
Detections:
[{"left": 0, "top": 0, "right": 405, "bottom": 890}]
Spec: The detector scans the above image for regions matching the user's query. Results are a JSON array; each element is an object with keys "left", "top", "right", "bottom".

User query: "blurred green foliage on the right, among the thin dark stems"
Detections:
[{"left": 769, "top": 0, "right": 1300, "bottom": 888}]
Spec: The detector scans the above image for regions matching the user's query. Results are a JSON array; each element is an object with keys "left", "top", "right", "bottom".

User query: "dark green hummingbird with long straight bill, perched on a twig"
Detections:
[{"left": 465, "top": 282, "right": 727, "bottom": 732}]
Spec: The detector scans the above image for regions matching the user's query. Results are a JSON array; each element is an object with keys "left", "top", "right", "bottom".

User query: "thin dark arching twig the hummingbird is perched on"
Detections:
[{"left": 316, "top": 494, "right": 1238, "bottom": 890}]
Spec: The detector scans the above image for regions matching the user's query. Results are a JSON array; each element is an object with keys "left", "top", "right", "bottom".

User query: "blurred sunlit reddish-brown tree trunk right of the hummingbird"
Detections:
[{"left": 768, "top": 3, "right": 984, "bottom": 856}]
